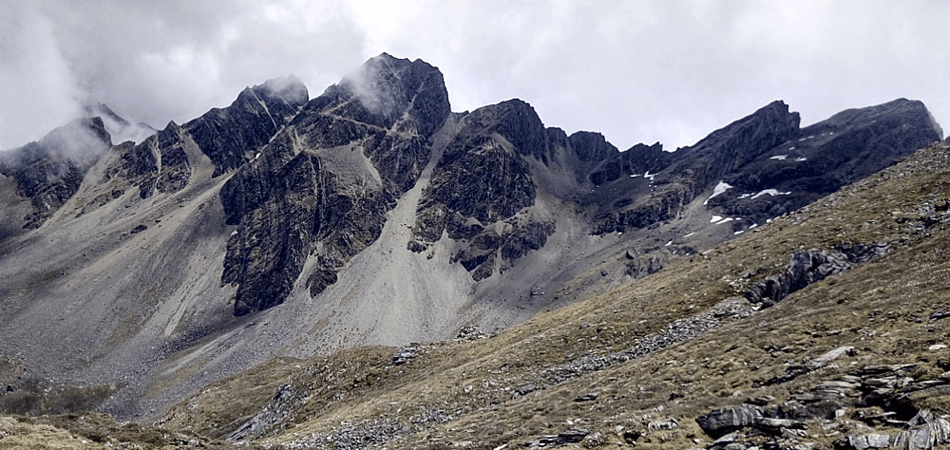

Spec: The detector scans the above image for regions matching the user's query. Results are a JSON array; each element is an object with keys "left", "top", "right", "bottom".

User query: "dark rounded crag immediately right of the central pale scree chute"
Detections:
[{"left": 409, "top": 100, "right": 556, "bottom": 281}]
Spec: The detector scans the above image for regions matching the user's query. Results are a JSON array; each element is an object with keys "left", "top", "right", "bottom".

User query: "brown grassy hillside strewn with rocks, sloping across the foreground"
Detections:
[{"left": 0, "top": 140, "right": 950, "bottom": 449}]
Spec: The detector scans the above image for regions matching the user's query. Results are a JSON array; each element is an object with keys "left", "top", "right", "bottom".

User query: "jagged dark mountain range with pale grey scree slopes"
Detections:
[{"left": 0, "top": 54, "right": 942, "bottom": 442}]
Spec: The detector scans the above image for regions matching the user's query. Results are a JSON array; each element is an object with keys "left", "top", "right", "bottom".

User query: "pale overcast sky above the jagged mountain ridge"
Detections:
[{"left": 0, "top": 0, "right": 950, "bottom": 150}]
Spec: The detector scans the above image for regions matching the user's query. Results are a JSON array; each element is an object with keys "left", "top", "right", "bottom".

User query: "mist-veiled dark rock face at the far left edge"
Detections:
[{"left": 0, "top": 118, "right": 112, "bottom": 229}]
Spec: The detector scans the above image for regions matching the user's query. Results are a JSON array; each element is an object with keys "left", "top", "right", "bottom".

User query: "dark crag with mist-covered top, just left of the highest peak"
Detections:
[{"left": 190, "top": 76, "right": 309, "bottom": 176}]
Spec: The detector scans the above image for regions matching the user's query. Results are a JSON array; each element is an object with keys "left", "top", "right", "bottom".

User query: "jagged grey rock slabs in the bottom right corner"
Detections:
[{"left": 696, "top": 364, "right": 950, "bottom": 450}]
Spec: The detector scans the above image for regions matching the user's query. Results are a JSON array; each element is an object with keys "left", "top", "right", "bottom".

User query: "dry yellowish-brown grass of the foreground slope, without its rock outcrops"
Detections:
[{"left": 158, "top": 141, "right": 950, "bottom": 448}]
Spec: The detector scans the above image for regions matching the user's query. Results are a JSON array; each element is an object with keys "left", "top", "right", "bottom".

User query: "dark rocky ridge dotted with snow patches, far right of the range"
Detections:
[{"left": 590, "top": 99, "right": 940, "bottom": 233}]
